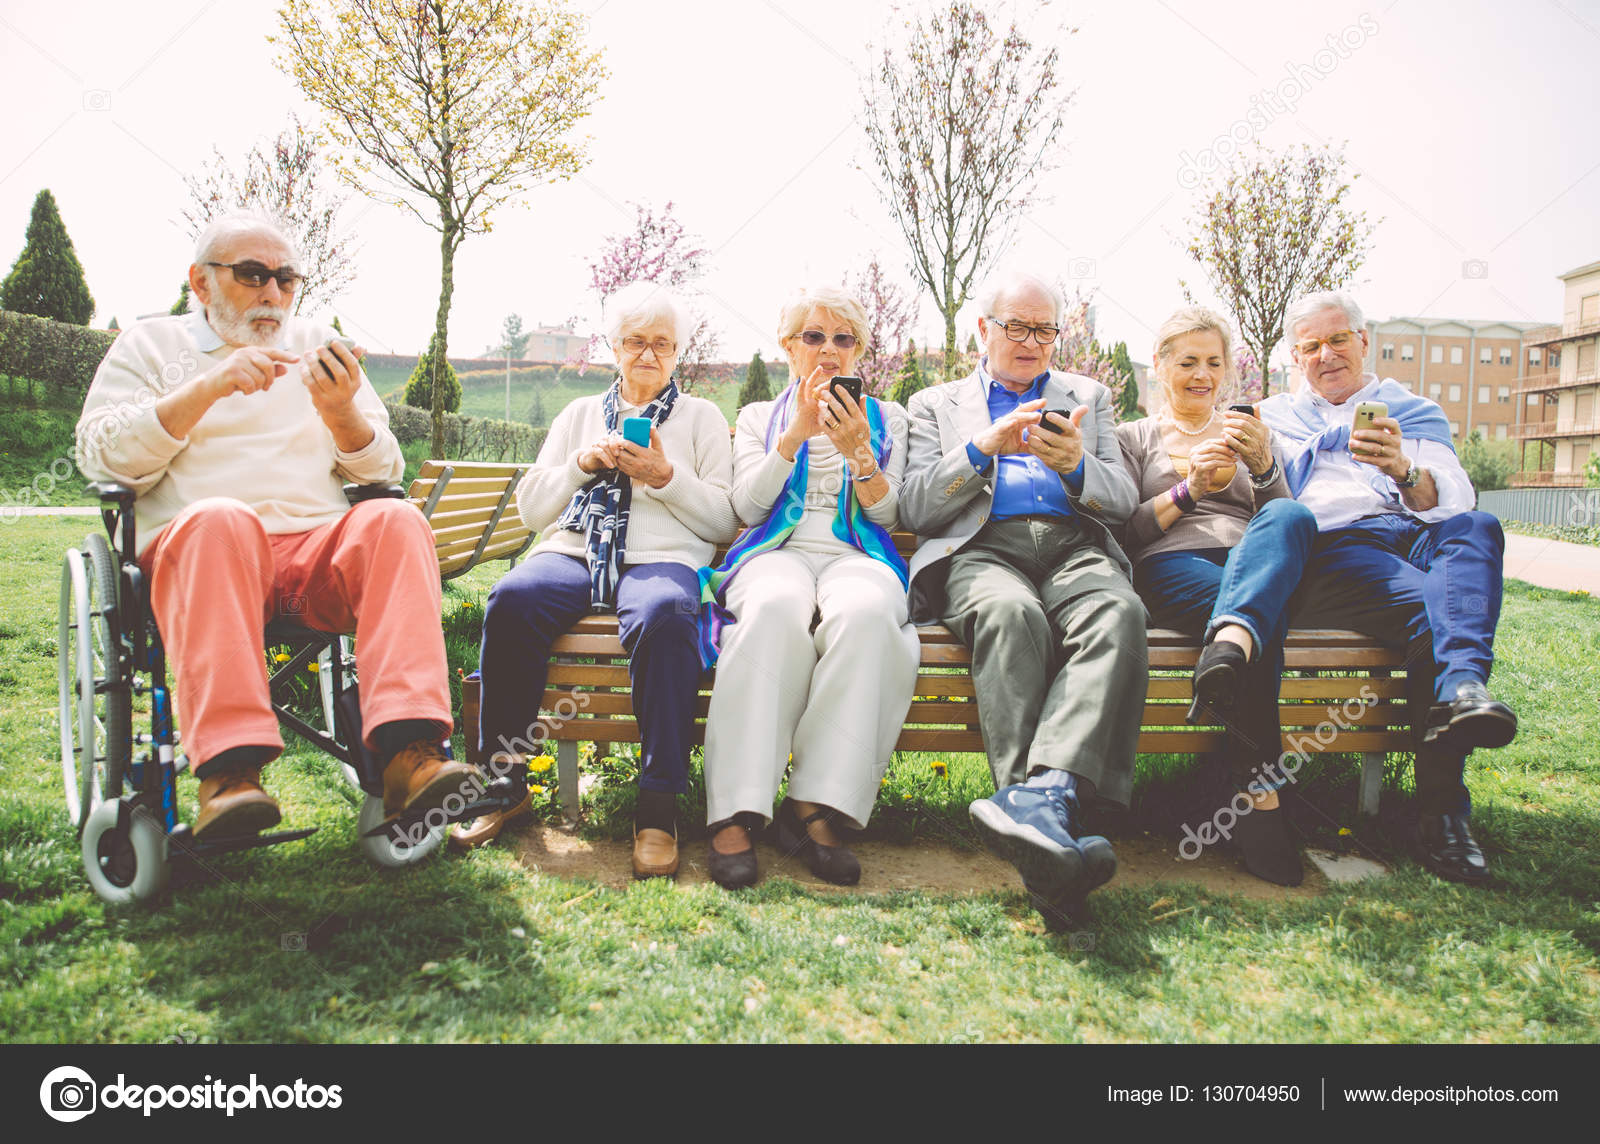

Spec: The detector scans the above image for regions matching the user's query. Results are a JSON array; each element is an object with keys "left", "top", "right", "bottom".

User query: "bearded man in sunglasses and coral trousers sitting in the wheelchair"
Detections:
[{"left": 77, "top": 214, "right": 472, "bottom": 840}]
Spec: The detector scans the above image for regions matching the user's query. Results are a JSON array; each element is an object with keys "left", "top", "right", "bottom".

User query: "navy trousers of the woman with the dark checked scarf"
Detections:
[{"left": 478, "top": 552, "right": 701, "bottom": 794}]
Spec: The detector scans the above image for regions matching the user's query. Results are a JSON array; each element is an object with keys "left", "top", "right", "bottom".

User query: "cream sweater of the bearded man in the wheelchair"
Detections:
[{"left": 77, "top": 314, "right": 405, "bottom": 552}]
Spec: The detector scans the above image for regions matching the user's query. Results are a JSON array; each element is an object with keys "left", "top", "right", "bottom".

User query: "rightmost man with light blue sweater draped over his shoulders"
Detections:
[{"left": 1259, "top": 291, "right": 1517, "bottom": 885}]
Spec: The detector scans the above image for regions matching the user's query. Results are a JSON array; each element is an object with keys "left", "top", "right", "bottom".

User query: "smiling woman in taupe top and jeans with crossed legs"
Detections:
[{"left": 1117, "top": 307, "right": 1317, "bottom": 886}]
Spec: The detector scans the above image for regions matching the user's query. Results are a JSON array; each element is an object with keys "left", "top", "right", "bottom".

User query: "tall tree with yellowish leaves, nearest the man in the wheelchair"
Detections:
[{"left": 272, "top": 0, "right": 606, "bottom": 456}]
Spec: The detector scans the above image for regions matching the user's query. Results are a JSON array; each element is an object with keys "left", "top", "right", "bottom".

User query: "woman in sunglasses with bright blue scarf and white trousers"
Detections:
[{"left": 701, "top": 288, "right": 920, "bottom": 890}]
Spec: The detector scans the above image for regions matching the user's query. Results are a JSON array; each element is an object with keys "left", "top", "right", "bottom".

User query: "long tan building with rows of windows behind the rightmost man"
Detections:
[{"left": 1366, "top": 317, "right": 1538, "bottom": 442}]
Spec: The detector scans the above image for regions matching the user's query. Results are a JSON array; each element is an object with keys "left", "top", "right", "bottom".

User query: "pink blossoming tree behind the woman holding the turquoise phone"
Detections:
[{"left": 571, "top": 202, "right": 717, "bottom": 390}]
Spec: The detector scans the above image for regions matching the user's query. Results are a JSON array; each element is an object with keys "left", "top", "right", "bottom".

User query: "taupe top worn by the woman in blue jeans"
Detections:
[{"left": 1117, "top": 418, "right": 1290, "bottom": 565}]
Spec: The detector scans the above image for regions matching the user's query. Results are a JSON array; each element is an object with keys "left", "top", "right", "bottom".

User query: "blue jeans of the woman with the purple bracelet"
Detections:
[{"left": 1133, "top": 498, "right": 1317, "bottom": 776}]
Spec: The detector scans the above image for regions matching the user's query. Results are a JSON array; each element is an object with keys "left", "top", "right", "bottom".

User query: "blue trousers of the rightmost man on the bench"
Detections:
[{"left": 1294, "top": 512, "right": 1506, "bottom": 813}]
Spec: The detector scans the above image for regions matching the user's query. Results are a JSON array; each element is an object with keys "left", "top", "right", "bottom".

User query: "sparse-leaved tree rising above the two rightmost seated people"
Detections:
[{"left": 1178, "top": 144, "right": 1376, "bottom": 397}]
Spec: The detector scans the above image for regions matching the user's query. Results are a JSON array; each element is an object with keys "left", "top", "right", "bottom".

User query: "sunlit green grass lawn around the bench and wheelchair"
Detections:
[{"left": 0, "top": 518, "right": 1600, "bottom": 1042}]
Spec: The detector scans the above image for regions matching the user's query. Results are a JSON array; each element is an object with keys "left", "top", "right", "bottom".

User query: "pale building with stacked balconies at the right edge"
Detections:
[{"left": 1512, "top": 262, "right": 1600, "bottom": 488}]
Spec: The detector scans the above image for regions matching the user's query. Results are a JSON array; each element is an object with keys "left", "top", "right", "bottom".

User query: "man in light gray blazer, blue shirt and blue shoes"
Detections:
[{"left": 899, "top": 272, "right": 1147, "bottom": 928}]
